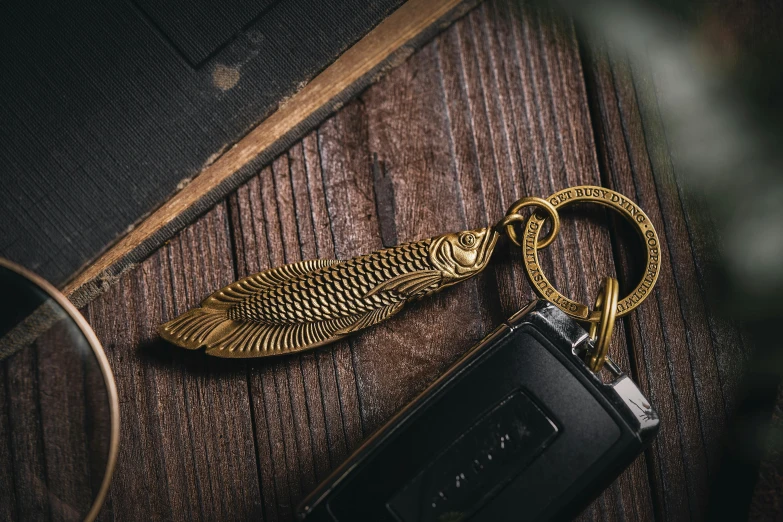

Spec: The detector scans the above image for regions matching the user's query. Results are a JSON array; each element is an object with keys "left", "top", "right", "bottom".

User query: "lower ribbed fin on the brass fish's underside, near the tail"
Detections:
[{"left": 204, "top": 317, "right": 356, "bottom": 357}]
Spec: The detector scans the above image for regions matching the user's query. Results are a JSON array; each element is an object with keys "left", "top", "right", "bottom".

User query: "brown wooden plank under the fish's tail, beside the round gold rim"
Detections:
[{"left": 86, "top": 204, "right": 262, "bottom": 520}]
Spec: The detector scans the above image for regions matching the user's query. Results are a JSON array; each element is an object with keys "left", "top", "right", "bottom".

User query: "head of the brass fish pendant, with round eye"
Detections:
[{"left": 430, "top": 227, "right": 498, "bottom": 282}]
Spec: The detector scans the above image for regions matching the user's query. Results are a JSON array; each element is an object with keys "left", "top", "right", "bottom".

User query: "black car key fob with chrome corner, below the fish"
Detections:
[{"left": 298, "top": 301, "right": 659, "bottom": 522}]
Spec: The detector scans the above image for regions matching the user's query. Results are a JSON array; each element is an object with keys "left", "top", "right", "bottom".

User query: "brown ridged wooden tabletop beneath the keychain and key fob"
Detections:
[{"left": 78, "top": 0, "right": 745, "bottom": 522}]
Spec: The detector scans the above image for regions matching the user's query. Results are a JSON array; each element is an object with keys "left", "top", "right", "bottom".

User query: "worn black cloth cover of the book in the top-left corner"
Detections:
[{"left": 0, "top": 0, "right": 402, "bottom": 286}]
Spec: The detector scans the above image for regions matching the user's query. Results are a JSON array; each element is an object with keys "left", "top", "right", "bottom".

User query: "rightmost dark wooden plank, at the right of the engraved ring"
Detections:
[{"left": 588, "top": 38, "right": 746, "bottom": 520}]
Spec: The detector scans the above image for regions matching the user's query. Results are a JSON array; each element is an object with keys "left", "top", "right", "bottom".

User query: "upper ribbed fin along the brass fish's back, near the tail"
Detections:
[{"left": 201, "top": 259, "right": 339, "bottom": 310}]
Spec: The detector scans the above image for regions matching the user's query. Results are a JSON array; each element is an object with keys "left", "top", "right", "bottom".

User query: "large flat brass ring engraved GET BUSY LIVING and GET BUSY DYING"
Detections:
[{"left": 522, "top": 186, "right": 661, "bottom": 323}]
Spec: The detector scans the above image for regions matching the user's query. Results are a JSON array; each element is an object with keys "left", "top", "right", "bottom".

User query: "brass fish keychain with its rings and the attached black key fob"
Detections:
[{"left": 160, "top": 182, "right": 660, "bottom": 522}]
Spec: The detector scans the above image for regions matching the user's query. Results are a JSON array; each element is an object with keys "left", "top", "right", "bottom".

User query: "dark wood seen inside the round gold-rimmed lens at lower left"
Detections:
[{"left": 0, "top": 318, "right": 110, "bottom": 521}]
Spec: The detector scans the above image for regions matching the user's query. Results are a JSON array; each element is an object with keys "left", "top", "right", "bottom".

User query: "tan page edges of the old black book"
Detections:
[{"left": 63, "top": 0, "right": 480, "bottom": 307}]
